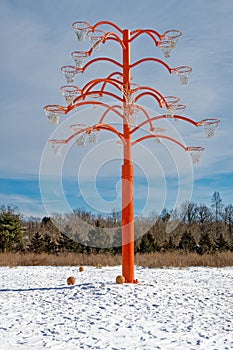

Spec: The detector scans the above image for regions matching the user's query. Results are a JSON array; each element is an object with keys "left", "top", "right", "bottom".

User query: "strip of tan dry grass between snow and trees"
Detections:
[{"left": 0, "top": 251, "right": 233, "bottom": 268}]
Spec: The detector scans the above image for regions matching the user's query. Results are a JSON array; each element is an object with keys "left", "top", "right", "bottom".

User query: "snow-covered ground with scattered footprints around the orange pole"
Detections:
[{"left": 0, "top": 266, "right": 233, "bottom": 350}]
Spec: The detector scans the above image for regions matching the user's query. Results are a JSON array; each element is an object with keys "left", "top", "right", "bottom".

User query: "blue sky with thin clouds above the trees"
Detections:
[{"left": 0, "top": 0, "right": 233, "bottom": 217}]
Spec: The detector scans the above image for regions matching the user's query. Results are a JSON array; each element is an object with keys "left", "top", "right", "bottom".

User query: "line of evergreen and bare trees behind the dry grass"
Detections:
[{"left": 0, "top": 192, "right": 233, "bottom": 254}]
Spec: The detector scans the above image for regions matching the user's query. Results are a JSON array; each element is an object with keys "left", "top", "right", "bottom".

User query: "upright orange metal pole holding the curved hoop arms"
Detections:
[{"left": 122, "top": 29, "right": 136, "bottom": 283}]
